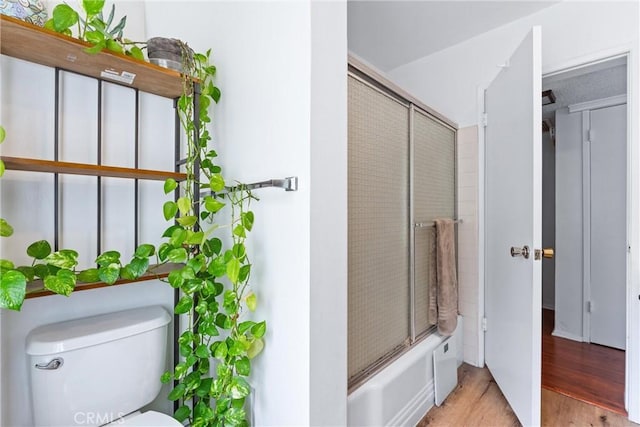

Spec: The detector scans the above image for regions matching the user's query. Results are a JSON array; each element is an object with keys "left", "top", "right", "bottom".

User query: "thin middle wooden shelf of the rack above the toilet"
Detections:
[{"left": 0, "top": 156, "right": 187, "bottom": 181}]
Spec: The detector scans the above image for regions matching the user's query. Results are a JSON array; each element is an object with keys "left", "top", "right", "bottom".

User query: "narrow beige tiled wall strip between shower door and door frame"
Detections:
[{"left": 456, "top": 126, "right": 481, "bottom": 366}]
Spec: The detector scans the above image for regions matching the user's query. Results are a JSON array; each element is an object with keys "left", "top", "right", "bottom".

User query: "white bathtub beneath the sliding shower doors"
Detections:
[{"left": 347, "top": 316, "right": 463, "bottom": 427}]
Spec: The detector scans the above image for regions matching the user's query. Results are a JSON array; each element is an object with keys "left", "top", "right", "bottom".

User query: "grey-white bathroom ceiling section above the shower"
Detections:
[{"left": 347, "top": 0, "right": 558, "bottom": 71}]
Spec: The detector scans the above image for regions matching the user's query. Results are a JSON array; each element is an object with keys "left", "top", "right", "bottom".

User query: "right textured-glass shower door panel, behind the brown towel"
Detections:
[{"left": 412, "top": 110, "right": 456, "bottom": 336}]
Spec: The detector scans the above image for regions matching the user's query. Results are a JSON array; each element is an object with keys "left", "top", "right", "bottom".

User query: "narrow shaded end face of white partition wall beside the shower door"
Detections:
[{"left": 309, "top": 1, "right": 348, "bottom": 426}]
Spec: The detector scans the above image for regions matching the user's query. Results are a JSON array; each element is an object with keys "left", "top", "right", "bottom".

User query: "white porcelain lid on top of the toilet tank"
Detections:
[{"left": 26, "top": 305, "right": 171, "bottom": 356}]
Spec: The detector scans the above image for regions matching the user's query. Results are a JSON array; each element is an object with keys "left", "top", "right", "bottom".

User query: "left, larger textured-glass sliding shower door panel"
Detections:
[{"left": 348, "top": 76, "right": 410, "bottom": 384}]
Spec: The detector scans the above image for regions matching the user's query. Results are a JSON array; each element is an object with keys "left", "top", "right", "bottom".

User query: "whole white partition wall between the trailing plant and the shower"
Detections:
[{"left": 147, "top": 1, "right": 347, "bottom": 425}]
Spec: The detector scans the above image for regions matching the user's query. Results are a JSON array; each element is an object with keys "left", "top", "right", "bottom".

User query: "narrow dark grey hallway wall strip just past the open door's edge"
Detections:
[{"left": 542, "top": 132, "right": 556, "bottom": 310}]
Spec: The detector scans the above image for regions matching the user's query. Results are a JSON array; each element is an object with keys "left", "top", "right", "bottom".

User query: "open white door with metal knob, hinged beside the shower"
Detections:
[{"left": 485, "top": 27, "right": 542, "bottom": 426}]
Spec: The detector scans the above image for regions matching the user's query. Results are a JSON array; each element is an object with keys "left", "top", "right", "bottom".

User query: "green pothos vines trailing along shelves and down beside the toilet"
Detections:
[{"left": 0, "top": 4, "right": 266, "bottom": 427}]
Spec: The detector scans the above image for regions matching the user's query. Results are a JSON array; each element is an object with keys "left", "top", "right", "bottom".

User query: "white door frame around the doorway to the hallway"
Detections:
[{"left": 477, "top": 40, "right": 640, "bottom": 423}]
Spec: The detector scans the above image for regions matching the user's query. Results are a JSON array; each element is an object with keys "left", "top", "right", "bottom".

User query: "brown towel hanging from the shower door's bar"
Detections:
[{"left": 434, "top": 219, "right": 458, "bottom": 336}]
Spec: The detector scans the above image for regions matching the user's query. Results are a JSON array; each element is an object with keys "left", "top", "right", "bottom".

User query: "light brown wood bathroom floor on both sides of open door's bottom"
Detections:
[{"left": 418, "top": 364, "right": 638, "bottom": 427}]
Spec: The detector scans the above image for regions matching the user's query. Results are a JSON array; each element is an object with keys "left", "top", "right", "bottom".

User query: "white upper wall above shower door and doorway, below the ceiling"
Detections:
[{"left": 388, "top": 1, "right": 638, "bottom": 127}]
